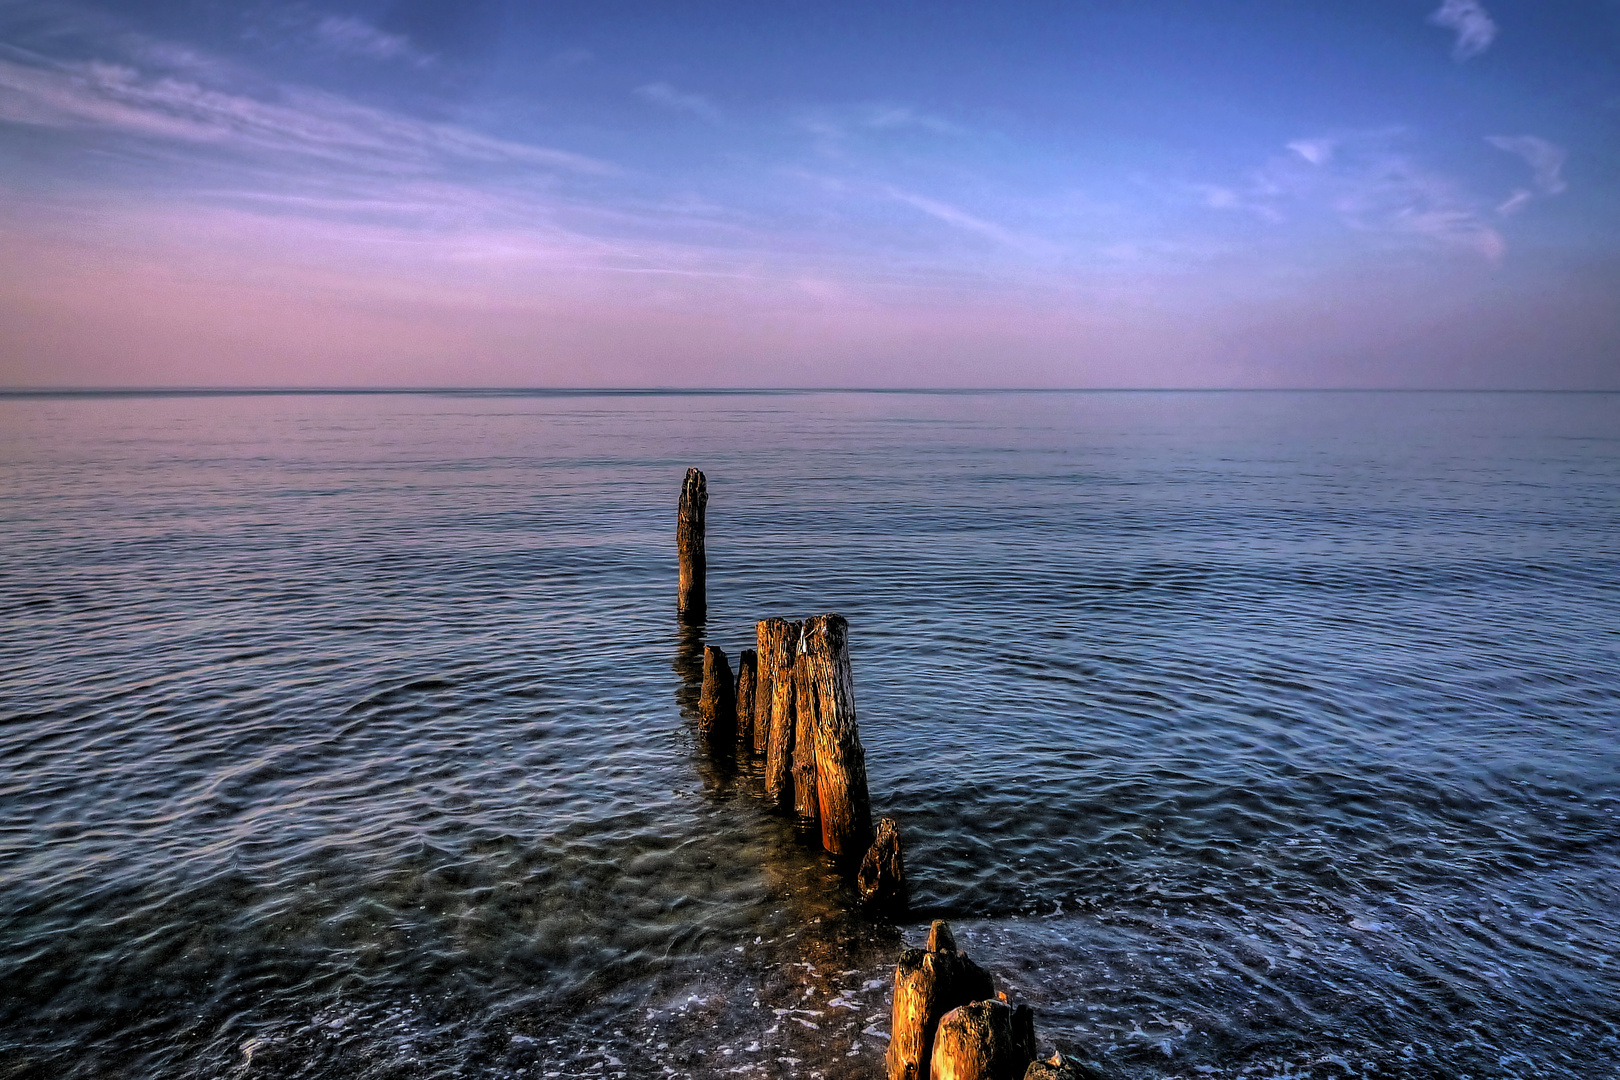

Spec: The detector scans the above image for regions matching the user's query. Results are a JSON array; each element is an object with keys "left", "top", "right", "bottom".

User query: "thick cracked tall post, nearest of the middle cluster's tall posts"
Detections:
[{"left": 804, "top": 615, "right": 872, "bottom": 858}]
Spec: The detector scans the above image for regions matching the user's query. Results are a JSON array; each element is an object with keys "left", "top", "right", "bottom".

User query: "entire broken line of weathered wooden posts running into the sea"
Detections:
[{"left": 676, "top": 468, "right": 1092, "bottom": 1080}]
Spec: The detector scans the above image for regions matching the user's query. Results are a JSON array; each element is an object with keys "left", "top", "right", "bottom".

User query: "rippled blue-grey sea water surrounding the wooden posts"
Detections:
[{"left": 0, "top": 393, "right": 1620, "bottom": 1080}]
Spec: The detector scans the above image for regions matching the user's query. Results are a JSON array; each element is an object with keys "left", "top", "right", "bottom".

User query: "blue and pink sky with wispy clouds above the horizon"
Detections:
[{"left": 0, "top": 0, "right": 1620, "bottom": 389}]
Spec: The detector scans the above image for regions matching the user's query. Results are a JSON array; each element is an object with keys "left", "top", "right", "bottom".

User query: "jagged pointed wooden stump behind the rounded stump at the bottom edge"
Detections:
[{"left": 888, "top": 920, "right": 995, "bottom": 1080}]
